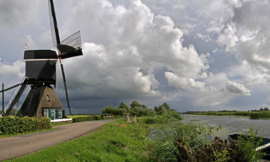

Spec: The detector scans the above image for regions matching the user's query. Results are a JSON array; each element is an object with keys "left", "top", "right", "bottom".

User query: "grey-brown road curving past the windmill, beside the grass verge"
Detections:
[{"left": 0, "top": 120, "right": 115, "bottom": 161}]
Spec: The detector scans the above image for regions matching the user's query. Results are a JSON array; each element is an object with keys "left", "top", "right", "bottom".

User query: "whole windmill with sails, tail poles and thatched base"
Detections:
[{"left": 0, "top": 0, "right": 83, "bottom": 119}]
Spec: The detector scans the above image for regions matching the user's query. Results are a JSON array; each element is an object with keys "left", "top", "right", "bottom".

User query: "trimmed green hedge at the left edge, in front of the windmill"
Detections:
[{"left": 0, "top": 117, "right": 52, "bottom": 135}]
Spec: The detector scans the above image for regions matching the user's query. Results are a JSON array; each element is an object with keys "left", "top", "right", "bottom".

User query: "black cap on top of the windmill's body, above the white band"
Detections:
[{"left": 24, "top": 50, "right": 58, "bottom": 60}]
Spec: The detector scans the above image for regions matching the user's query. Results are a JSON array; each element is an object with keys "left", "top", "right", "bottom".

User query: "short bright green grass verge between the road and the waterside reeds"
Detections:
[{"left": 6, "top": 120, "right": 153, "bottom": 162}]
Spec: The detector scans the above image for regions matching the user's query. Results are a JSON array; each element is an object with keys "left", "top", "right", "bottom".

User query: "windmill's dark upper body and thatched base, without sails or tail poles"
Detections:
[{"left": 17, "top": 50, "right": 65, "bottom": 120}]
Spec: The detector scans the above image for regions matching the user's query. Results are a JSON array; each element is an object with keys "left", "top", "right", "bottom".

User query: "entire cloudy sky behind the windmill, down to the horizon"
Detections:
[{"left": 0, "top": 0, "right": 270, "bottom": 114}]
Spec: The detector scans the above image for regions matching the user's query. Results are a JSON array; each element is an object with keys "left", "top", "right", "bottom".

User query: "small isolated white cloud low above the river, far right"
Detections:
[{"left": 226, "top": 81, "right": 251, "bottom": 96}]
